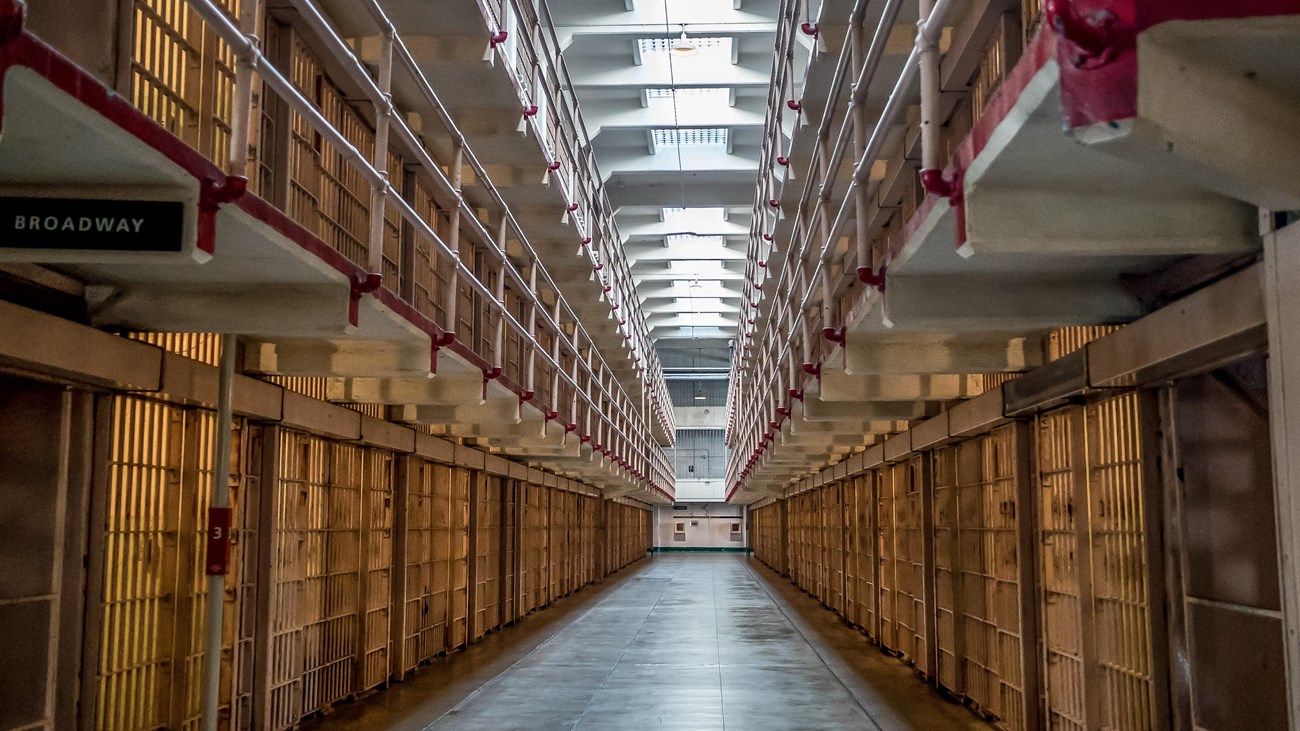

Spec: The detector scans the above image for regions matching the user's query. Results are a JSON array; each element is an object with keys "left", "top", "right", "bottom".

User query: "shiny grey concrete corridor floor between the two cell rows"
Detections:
[{"left": 306, "top": 554, "right": 991, "bottom": 731}]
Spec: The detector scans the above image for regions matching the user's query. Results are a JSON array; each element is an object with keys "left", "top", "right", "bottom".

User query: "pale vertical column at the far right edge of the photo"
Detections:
[{"left": 1264, "top": 217, "right": 1300, "bottom": 731}]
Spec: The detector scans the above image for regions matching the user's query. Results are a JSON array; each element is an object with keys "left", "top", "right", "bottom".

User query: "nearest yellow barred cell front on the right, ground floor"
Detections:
[{"left": 1039, "top": 393, "right": 1156, "bottom": 728}]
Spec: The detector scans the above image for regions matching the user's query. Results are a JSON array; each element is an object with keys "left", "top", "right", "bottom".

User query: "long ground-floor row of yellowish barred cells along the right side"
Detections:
[{"left": 751, "top": 387, "right": 1169, "bottom": 731}]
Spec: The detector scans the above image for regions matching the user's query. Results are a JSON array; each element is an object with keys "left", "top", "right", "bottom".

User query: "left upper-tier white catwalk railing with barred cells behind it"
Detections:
[{"left": 116, "top": 0, "right": 672, "bottom": 485}]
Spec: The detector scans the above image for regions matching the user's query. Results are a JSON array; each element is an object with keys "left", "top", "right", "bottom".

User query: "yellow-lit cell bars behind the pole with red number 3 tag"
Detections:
[{"left": 95, "top": 397, "right": 256, "bottom": 730}]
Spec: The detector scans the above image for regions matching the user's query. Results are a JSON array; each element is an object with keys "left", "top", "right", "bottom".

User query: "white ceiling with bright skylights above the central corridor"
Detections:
[{"left": 551, "top": 0, "right": 776, "bottom": 349}]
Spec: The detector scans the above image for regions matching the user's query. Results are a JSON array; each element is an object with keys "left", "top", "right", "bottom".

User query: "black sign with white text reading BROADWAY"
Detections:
[{"left": 0, "top": 196, "right": 185, "bottom": 251}]
